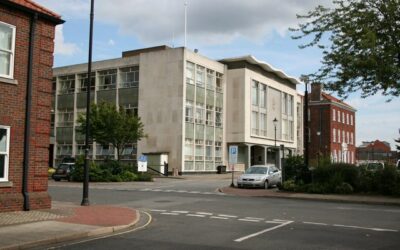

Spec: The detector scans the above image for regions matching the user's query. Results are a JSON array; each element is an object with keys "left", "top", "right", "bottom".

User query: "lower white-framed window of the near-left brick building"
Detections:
[{"left": 0, "top": 126, "right": 10, "bottom": 182}]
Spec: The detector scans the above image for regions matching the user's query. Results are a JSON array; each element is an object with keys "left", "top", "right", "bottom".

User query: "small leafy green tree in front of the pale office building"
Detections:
[{"left": 78, "top": 102, "right": 145, "bottom": 161}]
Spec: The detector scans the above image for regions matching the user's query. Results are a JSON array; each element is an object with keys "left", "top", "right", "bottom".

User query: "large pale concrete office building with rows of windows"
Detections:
[{"left": 53, "top": 46, "right": 298, "bottom": 173}]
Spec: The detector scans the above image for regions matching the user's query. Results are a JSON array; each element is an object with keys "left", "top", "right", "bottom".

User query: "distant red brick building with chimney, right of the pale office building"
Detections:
[{"left": 308, "top": 84, "right": 356, "bottom": 164}]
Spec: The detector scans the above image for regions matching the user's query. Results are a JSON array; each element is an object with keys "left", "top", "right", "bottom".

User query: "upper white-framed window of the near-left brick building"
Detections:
[{"left": 0, "top": 22, "right": 15, "bottom": 78}]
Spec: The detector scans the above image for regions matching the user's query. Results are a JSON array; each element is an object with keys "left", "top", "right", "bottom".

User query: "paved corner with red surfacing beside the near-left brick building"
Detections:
[{"left": 0, "top": 202, "right": 140, "bottom": 249}]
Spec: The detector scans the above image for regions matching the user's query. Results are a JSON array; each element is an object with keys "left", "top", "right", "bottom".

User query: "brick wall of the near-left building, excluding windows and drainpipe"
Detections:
[{"left": 0, "top": 5, "right": 55, "bottom": 212}]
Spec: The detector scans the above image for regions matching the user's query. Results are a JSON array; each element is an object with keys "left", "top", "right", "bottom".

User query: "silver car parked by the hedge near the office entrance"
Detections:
[{"left": 237, "top": 165, "right": 281, "bottom": 188}]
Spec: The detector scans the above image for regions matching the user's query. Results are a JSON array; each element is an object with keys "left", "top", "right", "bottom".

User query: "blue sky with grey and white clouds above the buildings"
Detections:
[{"left": 35, "top": 0, "right": 400, "bottom": 149}]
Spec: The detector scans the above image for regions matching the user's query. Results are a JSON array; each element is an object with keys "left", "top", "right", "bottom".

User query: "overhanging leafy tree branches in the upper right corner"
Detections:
[{"left": 290, "top": 0, "right": 400, "bottom": 99}]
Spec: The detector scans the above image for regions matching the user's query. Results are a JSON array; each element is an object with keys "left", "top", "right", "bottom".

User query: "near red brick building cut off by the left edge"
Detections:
[{"left": 0, "top": 0, "right": 64, "bottom": 212}]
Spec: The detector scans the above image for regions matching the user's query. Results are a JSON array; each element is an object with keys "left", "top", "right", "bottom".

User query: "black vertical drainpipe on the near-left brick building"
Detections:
[{"left": 22, "top": 13, "right": 38, "bottom": 211}]
